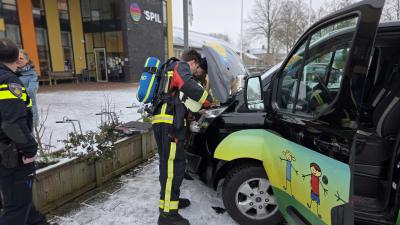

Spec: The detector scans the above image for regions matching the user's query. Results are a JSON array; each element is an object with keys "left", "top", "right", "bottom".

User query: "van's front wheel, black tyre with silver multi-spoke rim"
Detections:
[{"left": 223, "top": 165, "right": 283, "bottom": 225}]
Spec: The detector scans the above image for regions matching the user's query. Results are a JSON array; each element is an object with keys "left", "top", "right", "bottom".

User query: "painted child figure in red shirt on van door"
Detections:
[{"left": 302, "top": 162, "right": 328, "bottom": 218}]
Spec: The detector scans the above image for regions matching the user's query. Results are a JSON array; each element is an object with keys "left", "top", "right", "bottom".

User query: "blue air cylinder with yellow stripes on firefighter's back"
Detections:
[{"left": 136, "top": 57, "right": 161, "bottom": 104}]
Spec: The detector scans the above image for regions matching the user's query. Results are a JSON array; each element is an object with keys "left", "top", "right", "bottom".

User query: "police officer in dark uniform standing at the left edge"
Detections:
[{"left": 0, "top": 38, "right": 56, "bottom": 225}]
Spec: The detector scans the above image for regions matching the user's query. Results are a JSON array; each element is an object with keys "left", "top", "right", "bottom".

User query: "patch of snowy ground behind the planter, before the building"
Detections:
[{"left": 37, "top": 84, "right": 140, "bottom": 150}]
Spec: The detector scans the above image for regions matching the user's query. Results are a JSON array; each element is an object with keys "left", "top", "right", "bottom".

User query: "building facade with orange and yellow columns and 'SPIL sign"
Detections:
[{"left": 0, "top": 0, "right": 173, "bottom": 82}]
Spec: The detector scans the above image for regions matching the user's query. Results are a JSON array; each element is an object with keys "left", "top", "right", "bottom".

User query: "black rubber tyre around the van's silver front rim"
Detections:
[{"left": 222, "top": 164, "right": 283, "bottom": 225}]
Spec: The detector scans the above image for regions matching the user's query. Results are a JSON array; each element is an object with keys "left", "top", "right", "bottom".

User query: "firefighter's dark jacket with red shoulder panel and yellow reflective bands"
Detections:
[{"left": 152, "top": 62, "right": 212, "bottom": 139}]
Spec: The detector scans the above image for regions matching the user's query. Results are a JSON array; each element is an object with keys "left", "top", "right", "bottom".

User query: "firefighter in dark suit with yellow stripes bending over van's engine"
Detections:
[{"left": 152, "top": 50, "right": 212, "bottom": 225}]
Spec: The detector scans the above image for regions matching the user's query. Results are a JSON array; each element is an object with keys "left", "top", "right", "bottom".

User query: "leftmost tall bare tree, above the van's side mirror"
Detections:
[{"left": 247, "top": 0, "right": 282, "bottom": 53}]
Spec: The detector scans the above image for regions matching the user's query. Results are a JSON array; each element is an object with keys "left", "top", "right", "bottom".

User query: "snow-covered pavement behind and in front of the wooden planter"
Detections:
[{"left": 38, "top": 83, "right": 236, "bottom": 225}]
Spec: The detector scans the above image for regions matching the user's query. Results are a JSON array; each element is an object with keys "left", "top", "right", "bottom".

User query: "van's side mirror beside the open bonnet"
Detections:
[{"left": 244, "top": 76, "right": 265, "bottom": 111}]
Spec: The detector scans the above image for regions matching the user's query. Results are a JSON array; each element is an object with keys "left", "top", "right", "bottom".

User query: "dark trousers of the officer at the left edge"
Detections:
[{"left": 0, "top": 165, "right": 45, "bottom": 225}]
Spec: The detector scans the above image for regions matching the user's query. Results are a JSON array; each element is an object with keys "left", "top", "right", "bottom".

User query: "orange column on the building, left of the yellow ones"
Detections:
[{"left": 17, "top": 0, "right": 40, "bottom": 76}]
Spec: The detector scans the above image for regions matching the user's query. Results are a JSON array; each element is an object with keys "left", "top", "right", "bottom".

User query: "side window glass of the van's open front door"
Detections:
[{"left": 278, "top": 18, "right": 357, "bottom": 116}]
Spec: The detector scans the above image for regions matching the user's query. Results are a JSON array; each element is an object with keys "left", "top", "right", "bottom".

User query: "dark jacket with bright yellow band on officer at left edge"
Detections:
[{"left": 0, "top": 63, "right": 37, "bottom": 158}]
